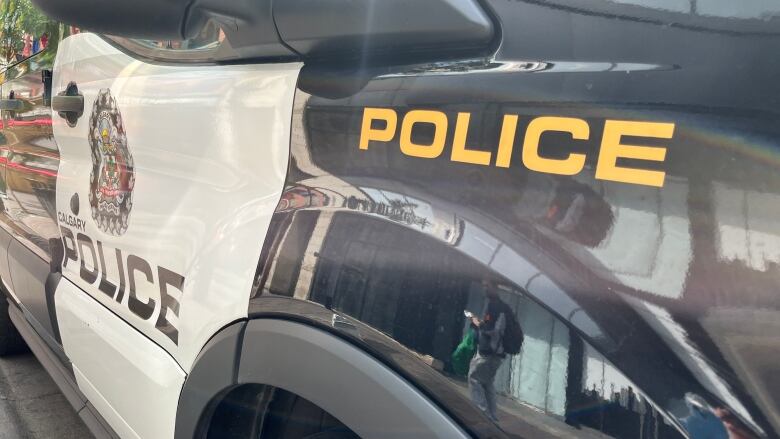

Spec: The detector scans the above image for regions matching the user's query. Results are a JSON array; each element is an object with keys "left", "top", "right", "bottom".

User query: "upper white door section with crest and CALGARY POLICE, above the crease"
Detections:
[{"left": 53, "top": 34, "right": 301, "bottom": 372}]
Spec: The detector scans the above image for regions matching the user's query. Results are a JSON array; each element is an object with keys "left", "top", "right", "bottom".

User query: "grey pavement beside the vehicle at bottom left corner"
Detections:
[{"left": 0, "top": 352, "right": 93, "bottom": 439}]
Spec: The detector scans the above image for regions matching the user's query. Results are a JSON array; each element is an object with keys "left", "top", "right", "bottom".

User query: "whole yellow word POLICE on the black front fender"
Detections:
[{"left": 359, "top": 108, "right": 674, "bottom": 187}]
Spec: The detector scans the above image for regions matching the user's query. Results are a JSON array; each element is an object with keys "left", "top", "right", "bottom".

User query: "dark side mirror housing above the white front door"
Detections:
[{"left": 33, "top": 0, "right": 499, "bottom": 66}]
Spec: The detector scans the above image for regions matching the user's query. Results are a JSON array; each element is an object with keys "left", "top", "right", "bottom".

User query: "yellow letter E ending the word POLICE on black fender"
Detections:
[{"left": 596, "top": 120, "right": 674, "bottom": 187}]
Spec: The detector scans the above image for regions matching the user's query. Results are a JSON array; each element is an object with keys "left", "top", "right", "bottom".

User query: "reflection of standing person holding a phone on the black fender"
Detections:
[{"left": 468, "top": 279, "right": 512, "bottom": 421}]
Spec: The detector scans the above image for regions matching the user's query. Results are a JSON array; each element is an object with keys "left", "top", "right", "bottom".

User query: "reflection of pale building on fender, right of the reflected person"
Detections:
[{"left": 488, "top": 293, "right": 677, "bottom": 438}]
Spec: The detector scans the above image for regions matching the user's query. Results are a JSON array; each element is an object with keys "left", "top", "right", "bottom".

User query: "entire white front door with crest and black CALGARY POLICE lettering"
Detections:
[{"left": 48, "top": 29, "right": 301, "bottom": 437}]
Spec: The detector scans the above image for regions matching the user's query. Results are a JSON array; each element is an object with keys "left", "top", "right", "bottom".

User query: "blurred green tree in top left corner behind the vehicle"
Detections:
[{"left": 0, "top": 0, "right": 61, "bottom": 64}]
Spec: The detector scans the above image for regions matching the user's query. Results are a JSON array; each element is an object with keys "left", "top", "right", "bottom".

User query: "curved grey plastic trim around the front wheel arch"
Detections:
[{"left": 175, "top": 318, "right": 468, "bottom": 439}]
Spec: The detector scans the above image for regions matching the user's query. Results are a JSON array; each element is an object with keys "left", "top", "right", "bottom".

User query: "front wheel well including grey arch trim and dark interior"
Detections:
[{"left": 175, "top": 318, "right": 466, "bottom": 439}]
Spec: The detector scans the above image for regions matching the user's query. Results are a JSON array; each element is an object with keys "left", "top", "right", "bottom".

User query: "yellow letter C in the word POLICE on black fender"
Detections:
[{"left": 523, "top": 117, "right": 590, "bottom": 175}]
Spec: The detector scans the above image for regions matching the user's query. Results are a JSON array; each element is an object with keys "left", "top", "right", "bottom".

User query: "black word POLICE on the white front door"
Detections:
[{"left": 60, "top": 225, "right": 184, "bottom": 345}]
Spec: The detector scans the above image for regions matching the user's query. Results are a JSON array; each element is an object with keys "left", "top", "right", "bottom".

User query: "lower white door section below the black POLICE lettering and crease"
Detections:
[{"left": 54, "top": 279, "right": 186, "bottom": 438}]
